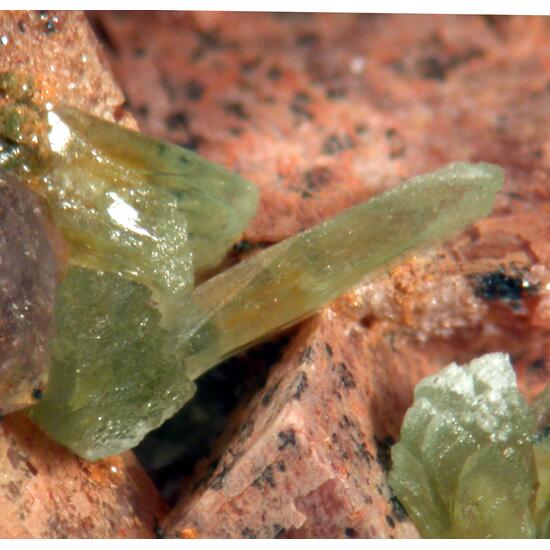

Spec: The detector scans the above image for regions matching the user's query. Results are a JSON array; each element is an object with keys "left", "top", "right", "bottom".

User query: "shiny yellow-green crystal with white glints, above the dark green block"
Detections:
[{"left": 0, "top": 80, "right": 258, "bottom": 309}]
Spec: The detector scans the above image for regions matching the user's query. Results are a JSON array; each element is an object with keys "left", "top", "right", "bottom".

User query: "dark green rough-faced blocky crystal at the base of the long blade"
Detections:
[{"left": 29, "top": 267, "right": 195, "bottom": 460}]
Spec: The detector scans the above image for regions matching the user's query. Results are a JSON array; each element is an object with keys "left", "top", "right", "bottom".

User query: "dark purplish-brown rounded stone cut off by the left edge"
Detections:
[{"left": 0, "top": 171, "right": 57, "bottom": 414}]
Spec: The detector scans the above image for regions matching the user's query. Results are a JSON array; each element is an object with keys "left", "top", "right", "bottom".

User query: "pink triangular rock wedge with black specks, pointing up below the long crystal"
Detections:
[{"left": 164, "top": 310, "right": 426, "bottom": 538}]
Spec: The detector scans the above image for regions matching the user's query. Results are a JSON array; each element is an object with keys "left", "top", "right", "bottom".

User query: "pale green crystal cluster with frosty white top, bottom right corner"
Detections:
[{"left": 389, "top": 353, "right": 550, "bottom": 538}]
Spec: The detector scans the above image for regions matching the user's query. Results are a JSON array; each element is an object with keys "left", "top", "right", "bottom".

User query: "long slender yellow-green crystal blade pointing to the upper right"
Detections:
[{"left": 168, "top": 163, "right": 503, "bottom": 378}]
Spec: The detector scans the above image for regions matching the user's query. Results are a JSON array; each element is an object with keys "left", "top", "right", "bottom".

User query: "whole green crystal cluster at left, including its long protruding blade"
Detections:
[{"left": 0, "top": 71, "right": 503, "bottom": 460}]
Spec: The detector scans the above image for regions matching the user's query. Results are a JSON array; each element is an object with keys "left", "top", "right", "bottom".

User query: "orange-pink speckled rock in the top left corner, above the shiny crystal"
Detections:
[{"left": 0, "top": 11, "right": 135, "bottom": 127}]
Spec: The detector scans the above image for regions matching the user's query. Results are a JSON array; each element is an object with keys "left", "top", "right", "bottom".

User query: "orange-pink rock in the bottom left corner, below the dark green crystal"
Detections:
[{"left": 0, "top": 413, "right": 164, "bottom": 538}]
